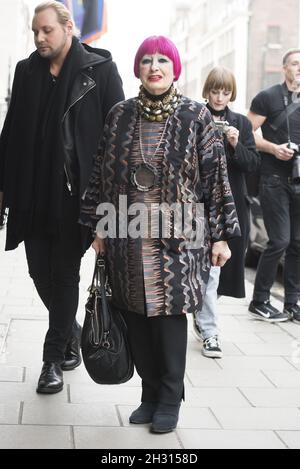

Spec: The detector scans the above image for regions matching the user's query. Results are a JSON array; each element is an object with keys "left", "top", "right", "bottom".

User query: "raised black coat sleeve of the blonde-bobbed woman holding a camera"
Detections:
[{"left": 226, "top": 115, "right": 261, "bottom": 173}]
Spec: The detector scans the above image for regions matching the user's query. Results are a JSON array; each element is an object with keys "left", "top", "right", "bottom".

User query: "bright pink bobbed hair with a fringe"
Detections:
[{"left": 134, "top": 36, "right": 181, "bottom": 81}]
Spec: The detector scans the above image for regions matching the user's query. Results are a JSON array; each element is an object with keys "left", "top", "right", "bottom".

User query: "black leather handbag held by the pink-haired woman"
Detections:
[{"left": 81, "top": 255, "right": 134, "bottom": 384}]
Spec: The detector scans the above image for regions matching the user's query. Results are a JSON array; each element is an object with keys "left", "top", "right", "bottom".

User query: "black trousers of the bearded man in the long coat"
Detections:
[{"left": 25, "top": 191, "right": 83, "bottom": 363}]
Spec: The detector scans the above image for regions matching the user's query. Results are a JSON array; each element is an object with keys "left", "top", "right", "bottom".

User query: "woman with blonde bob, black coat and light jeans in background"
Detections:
[{"left": 194, "top": 67, "right": 260, "bottom": 358}]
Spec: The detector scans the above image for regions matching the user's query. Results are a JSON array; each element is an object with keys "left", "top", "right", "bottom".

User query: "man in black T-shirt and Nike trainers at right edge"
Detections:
[{"left": 248, "top": 49, "right": 300, "bottom": 324}]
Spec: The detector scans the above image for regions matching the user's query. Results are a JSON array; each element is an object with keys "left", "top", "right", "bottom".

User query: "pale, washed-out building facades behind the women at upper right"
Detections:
[{"left": 170, "top": 0, "right": 300, "bottom": 112}]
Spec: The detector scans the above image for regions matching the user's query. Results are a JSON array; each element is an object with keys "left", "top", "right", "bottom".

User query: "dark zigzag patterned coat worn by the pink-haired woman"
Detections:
[{"left": 80, "top": 98, "right": 240, "bottom": 317}]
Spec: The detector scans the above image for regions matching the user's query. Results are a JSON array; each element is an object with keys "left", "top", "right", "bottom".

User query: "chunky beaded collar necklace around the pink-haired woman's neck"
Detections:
[{"left": 138, "top": 86, "right": 181, "bottom": 122}]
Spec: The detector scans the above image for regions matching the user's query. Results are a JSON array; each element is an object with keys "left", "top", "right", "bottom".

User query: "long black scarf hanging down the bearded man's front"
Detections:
[{"left": 8, "top": 38, "right": 82, "bottom": 242}]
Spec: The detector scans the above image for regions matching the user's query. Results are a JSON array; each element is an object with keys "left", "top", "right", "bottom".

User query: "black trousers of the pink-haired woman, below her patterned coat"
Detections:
[{"left": 124, "top": 312, "right": 187, "bottom": 404}]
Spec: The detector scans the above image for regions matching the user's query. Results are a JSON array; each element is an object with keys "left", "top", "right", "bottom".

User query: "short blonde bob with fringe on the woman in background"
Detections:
[{"left": 202, "top": 67, "right": 237, "bottom": 101}]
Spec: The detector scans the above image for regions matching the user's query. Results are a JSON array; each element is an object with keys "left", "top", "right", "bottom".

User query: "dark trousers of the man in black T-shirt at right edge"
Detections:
[{"left": 253, "top": 175, "right": 300, "bottom": 303}]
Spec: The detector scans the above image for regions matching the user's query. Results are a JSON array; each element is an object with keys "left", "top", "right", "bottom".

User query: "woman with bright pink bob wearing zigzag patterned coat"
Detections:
[{"left": 81, "top": 36, "right": 239, "bottom": 433}]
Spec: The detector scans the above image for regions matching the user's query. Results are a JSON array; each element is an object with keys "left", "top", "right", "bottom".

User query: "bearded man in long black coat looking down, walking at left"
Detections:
[{"left": 0, "top": 1, "right": 124, "bottom": 394}]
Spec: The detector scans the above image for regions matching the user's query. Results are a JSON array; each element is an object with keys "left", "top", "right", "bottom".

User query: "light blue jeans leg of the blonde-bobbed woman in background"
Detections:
[{"left": 196, "top": 267, "right": 221, "bottom": 340}]
